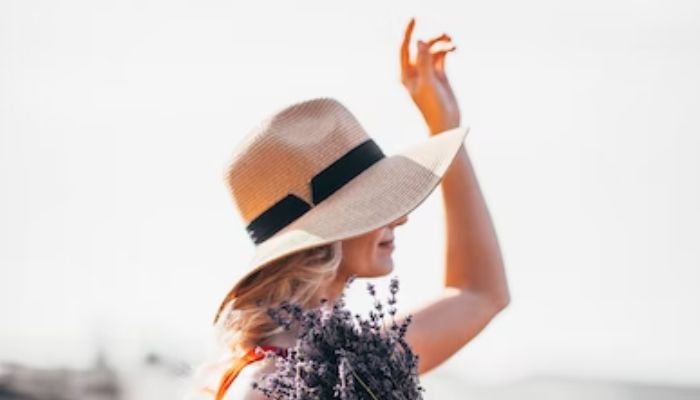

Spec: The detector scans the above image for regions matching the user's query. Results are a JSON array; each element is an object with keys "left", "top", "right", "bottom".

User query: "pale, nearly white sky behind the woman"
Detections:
[{"left": 0, "top": 0, "right": 700, "bottom": 390}]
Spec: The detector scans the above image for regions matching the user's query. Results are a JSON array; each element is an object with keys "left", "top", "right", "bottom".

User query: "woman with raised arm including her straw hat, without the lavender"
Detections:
[{"left": 189, "top": 19, "right": 509, "bottom": 400}]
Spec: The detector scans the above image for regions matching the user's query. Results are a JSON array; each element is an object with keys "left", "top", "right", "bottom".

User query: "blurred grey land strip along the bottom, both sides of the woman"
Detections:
[{"left": 0, "top": 353, "right": 700, "bottom": 400}]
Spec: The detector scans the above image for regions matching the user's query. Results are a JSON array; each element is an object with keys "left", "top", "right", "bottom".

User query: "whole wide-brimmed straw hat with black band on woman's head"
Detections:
[{"left": 214, "top": 97, "right": 469, "bottom": 323}]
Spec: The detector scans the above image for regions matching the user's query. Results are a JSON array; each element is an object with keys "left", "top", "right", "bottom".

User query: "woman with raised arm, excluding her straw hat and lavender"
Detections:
[{"left": 190, "top": 19, "right": 509, "bottom": 400}]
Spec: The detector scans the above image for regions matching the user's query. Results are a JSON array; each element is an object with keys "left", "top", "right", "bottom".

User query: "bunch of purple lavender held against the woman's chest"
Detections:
[{"left": 252, "top": 276, "right": 425, "bottom": 400}]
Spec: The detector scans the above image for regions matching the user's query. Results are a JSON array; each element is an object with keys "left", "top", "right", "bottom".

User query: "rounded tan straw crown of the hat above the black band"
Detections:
[{"left": 225, "top": 97, "right": 378, "bottom": 230}]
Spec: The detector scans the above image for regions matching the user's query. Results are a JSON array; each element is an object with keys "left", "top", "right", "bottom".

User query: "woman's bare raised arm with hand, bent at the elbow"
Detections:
[{"left": 398, "top": 19, "right": 510, "bottom": 374}]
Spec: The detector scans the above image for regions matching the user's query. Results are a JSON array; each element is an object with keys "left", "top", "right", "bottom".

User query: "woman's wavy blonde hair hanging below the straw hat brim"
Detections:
[{"left": 180, "top": 241, "right": 342, "bottom": 399}]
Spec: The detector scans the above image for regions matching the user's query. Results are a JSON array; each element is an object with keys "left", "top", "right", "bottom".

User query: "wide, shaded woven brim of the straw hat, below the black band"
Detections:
[{"left": 215, "top": 126, "right": 469, "bottom": 321}]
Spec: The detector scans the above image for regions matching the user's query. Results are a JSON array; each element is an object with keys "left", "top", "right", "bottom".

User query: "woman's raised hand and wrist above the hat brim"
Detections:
[{"left": 401, "top": 18, "right": 460, "bottom": 135}]
